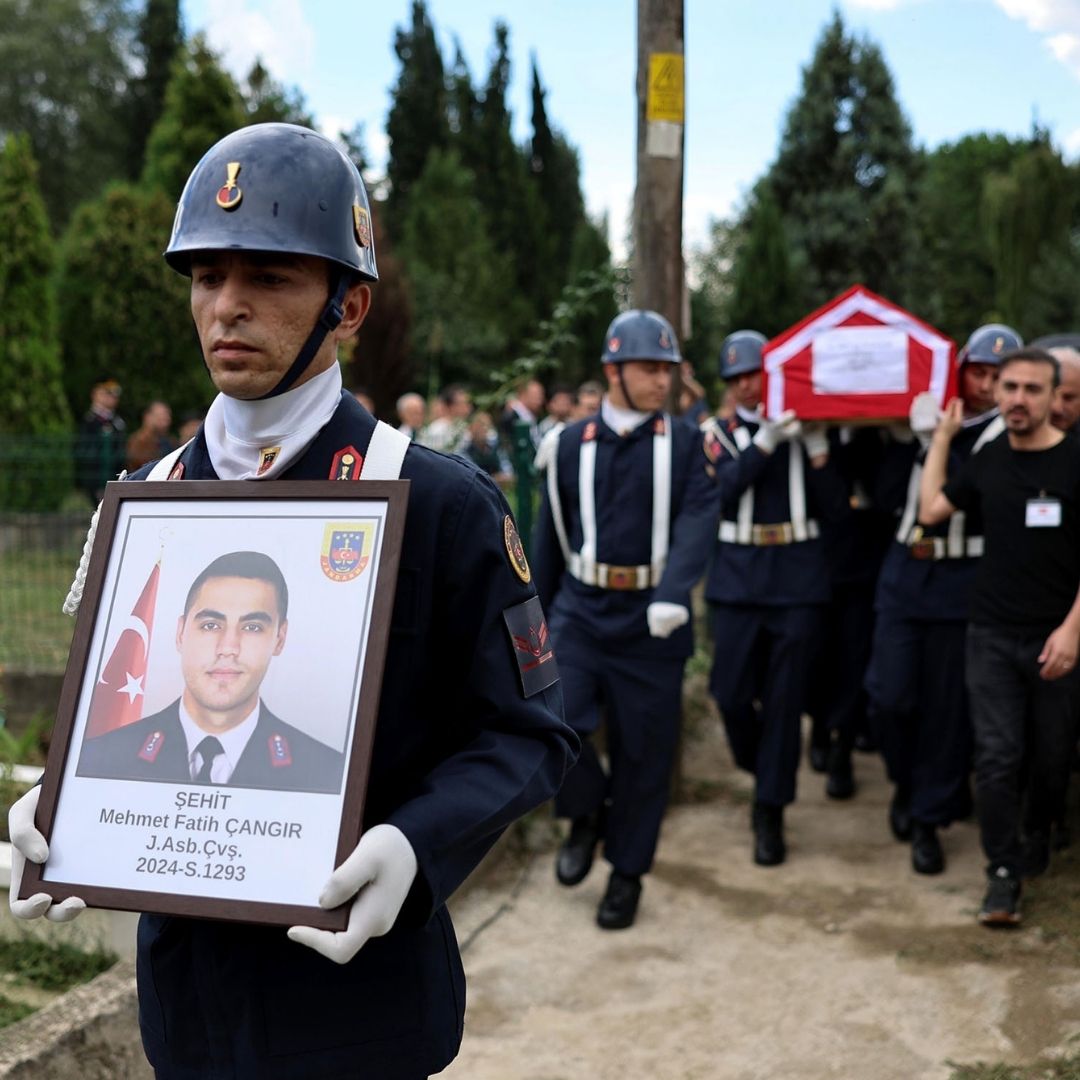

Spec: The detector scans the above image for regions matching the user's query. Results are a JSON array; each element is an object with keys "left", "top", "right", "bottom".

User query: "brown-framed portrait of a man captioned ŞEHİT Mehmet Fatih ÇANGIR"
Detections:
[{"left": 21, "top": 481, "right": 408, "bottom": 930}]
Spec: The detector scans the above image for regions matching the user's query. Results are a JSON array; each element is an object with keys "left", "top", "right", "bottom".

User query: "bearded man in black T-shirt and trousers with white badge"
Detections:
[{"left": 919, "top": 349, "right": 1080, "bottom": 926}]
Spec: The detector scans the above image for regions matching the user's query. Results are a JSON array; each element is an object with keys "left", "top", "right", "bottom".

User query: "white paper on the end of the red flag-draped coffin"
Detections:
[{"left": 811, "top": 326, "right": 908, "bottom": 394}]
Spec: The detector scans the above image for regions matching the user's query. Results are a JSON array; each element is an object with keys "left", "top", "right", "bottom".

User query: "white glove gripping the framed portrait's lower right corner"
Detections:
[{"left": 288, "top": 825, "right": 417, "bottom": 963}]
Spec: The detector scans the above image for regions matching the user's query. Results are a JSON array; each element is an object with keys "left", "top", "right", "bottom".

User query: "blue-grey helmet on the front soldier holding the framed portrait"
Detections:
[{"left": 165, "top": 123, "right": 379, "bottom": 281}]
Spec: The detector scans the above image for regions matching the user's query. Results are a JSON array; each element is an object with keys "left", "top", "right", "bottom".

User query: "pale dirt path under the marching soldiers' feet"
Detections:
[{"left": 442, "top": 682, "right": 1080, "bottom": 1080}]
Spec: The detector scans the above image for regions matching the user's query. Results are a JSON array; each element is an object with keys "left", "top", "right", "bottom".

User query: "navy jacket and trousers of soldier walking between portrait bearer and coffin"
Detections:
[{"left": 534, "top": 415, "right": 716, "bottom": 876}]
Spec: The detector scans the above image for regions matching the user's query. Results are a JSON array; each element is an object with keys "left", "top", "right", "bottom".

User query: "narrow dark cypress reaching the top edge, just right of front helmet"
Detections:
[{"left": 387, "top": 0, "right": 450, "bottom": 232}]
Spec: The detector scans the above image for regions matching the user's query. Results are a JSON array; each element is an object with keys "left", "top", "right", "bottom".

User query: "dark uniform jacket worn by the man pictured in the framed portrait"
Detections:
[{"left": 79, "top": 698, "right": 345, "bottom": 793}]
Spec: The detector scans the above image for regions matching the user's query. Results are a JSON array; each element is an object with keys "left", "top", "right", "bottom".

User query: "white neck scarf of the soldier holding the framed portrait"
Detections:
[{"left": 203, "top": 364, "right": 341, "bottom": 480}]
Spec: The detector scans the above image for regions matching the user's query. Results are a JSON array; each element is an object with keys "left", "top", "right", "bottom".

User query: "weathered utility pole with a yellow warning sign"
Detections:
[{"left": 633, "top": 0, "right": 689, "bottom": 339}]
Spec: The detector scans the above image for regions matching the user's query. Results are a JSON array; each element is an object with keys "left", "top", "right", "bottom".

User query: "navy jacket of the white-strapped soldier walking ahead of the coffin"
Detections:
[{"left": 532, "top": 413, "right": 717, "bottom": 659}]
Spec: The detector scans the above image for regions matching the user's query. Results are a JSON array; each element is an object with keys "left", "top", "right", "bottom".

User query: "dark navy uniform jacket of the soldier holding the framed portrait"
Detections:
[{"left": 123, "top": 393, "right": 578, "bottom": 1080}]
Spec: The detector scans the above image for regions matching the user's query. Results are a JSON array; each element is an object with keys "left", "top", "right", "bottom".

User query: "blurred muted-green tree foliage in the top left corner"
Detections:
[{"left": 0, "top": 0, "right": 134, "bottom": 232}]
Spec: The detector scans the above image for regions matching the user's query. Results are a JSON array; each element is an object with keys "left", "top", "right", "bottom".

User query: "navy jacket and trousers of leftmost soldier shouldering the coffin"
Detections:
[{"left": 705, "top": 418, "right": 847, "bottom": 807}]
